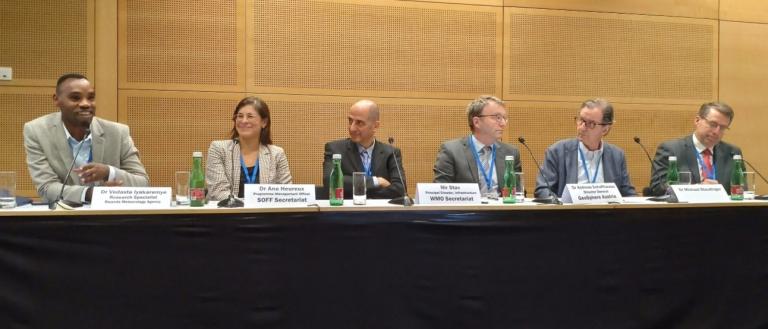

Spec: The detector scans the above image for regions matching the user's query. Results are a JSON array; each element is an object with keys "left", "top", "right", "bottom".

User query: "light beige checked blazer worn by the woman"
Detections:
[{"left": 205, "top": 140, "right": 293, "bottom": 201}]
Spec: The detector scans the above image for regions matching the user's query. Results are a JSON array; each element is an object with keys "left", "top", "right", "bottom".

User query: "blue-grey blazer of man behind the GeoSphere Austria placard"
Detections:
[{"left": 535, "top": 138, "right": 637, "bottom": 198}]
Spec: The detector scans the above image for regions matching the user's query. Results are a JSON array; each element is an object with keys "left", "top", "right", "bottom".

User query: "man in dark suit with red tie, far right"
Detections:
[{"left": 650, "top": 102, "right": 741, "bottom": 195}]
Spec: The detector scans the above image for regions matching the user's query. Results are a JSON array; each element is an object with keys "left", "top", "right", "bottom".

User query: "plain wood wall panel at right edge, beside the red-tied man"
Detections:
[{"left": 720, "top": 21, "right": 768, "bottom": 194}]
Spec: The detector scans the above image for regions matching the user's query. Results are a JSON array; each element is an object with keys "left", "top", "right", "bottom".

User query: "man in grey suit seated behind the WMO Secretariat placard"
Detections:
[{"left": 432, "top": 96, "right": 523, "bottom": 198}]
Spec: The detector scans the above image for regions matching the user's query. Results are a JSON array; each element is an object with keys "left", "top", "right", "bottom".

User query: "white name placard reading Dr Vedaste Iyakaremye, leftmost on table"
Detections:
[{"left": 91, "top": 186, "right": 171, "bottom": 209}]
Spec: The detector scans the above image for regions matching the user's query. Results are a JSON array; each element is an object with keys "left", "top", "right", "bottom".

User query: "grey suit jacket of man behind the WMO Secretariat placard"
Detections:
[{"left": 432, "top": 136, "right": 523, "bottom": 192}]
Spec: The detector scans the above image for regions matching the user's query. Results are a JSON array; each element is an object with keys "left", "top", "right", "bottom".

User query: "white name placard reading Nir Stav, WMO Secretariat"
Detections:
[{"left": 416, "top": 183, "right": 480, "bottom": 204}]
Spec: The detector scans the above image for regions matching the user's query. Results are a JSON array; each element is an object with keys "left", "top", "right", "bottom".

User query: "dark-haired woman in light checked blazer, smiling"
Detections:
[{"left": 205, "top": 96, "right": 291, "bottom": 201}]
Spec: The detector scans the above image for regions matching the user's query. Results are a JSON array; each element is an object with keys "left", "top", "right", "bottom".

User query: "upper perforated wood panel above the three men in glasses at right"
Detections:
[{"left": 504, "top": 8, "right": 718, "bottom": 104}]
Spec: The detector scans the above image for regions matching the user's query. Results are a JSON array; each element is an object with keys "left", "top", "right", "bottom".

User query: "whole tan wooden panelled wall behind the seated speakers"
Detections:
[{"left": 0, "top": 0, "right": 768, "bottom": 195}]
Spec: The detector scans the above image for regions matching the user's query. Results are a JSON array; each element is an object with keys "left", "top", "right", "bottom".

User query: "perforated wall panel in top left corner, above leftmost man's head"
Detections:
[{"left": 0, "top": 0, "right": 94, "bottom": 87}]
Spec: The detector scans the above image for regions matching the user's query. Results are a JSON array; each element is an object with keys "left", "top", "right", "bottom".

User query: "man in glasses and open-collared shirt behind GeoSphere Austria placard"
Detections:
[{"left": 535, "top": 98, "right": 637, "bottom": 198}]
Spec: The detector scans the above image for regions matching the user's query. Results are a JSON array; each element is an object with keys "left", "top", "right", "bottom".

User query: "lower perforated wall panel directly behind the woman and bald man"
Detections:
[{"left": 120, "top": 91, "right": 476, "bottom": 192}]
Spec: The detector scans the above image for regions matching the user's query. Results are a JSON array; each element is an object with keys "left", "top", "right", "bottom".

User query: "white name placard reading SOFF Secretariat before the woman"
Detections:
[{"left": 243, "top": 184, "right": 315, "bottom": 208}]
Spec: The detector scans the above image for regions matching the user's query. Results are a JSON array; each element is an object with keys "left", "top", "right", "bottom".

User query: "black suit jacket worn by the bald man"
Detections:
[{"left": 320, "top": 138, "right": 405, "bottom": 199}]
